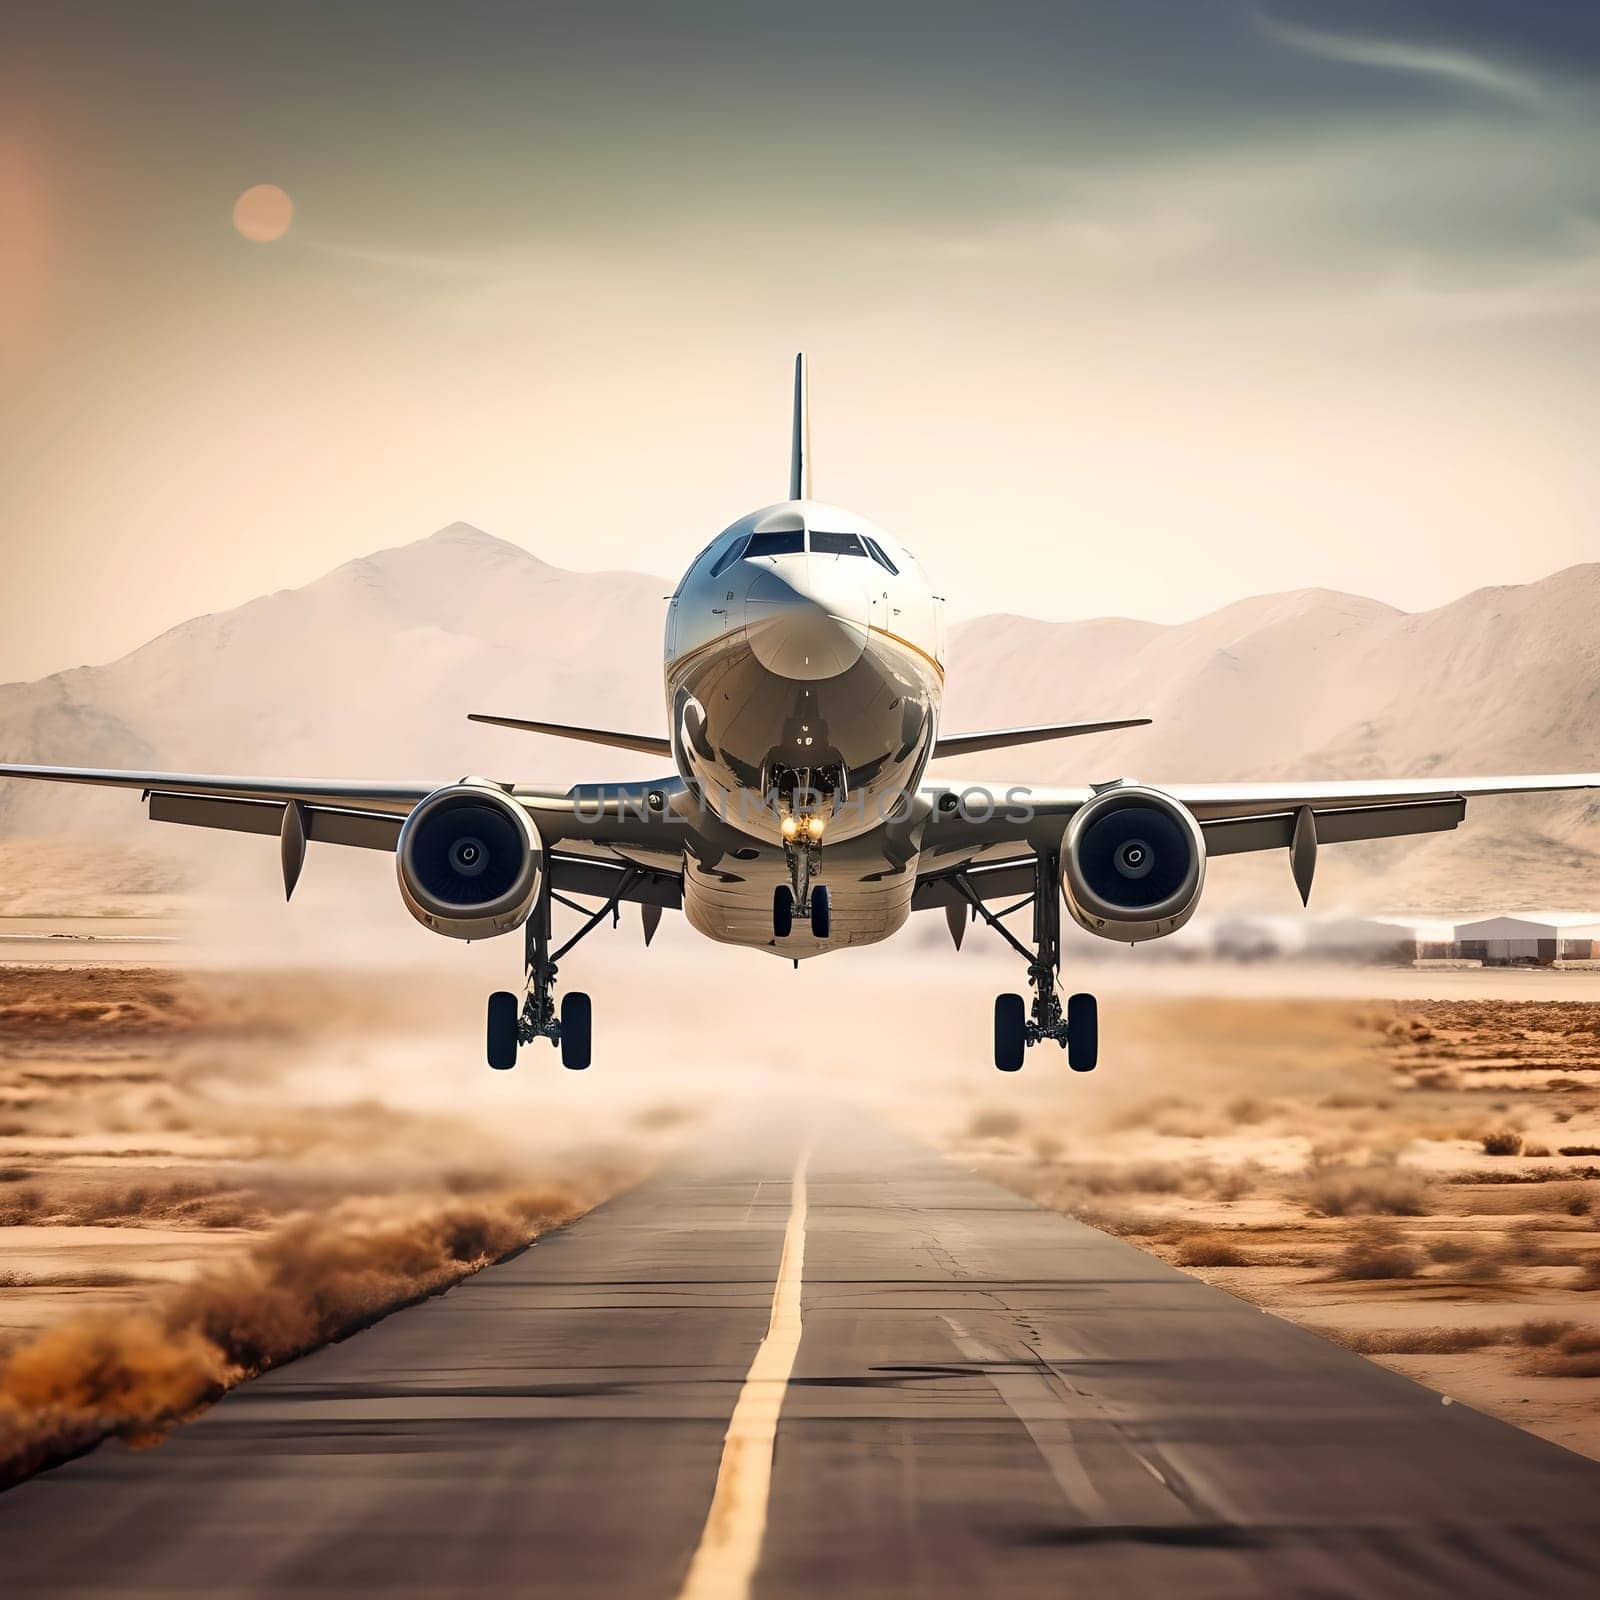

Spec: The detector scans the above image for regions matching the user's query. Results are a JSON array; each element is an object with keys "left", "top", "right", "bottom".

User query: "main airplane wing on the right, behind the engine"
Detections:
[{"left": 912, "top": 773, "right": 1600, "bottom": 909}]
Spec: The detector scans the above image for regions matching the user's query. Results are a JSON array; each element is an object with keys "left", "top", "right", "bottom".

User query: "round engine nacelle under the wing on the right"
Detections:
[{"left": 1061, "top": 784, "right": 1205, "bottom": 944}]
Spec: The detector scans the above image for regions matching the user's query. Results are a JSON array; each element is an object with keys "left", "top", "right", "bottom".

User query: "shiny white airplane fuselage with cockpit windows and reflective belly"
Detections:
[{"left": 666, "top": 499, "right": 944, "bottom": 957}]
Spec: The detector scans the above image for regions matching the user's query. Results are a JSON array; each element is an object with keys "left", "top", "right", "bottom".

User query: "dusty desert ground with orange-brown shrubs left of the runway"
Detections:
[{"left": 0, "top": 965, "right": 683, "bottom": 1485}]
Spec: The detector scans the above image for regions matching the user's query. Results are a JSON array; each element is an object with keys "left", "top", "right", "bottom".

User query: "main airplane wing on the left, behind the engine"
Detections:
[{"left": 0, "top": 763, "right": 683, "bottom": 909}]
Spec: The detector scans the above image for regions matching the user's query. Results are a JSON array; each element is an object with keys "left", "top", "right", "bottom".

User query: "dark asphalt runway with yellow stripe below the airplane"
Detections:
[{"left": 0, "top": 1117, "right": 1600, "bottom": 1600}]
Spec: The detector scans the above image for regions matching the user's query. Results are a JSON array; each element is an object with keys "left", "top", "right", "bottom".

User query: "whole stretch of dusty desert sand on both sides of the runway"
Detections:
[{"left": 0, "top": 912, "right": 1600, "bottom": 1472}]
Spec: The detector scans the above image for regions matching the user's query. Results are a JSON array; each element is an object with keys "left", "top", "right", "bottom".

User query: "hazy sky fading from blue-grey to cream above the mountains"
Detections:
[{"left": 0, "top": 0, "right": 1600, "bottom": 680}]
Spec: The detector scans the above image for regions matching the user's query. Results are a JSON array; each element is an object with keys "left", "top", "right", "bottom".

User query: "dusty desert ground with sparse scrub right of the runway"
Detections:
[{"left": 930, "top": 989, "right": 1600, "bottom": 1458}]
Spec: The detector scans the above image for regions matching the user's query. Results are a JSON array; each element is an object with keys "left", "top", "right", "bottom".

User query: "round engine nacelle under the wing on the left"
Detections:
[{"left": 395, "top": 778, "right": 544, "bottom": 939}]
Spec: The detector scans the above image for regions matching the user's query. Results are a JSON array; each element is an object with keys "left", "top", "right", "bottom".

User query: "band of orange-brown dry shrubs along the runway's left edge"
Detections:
[{"left": 0, "top": 1184, "right": 605, "bottom": 1486}]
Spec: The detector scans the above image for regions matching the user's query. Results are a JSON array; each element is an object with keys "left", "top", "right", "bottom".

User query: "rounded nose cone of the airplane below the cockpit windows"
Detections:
[{"left": 744, "top": 557, "right": 869, "bottom": 680}]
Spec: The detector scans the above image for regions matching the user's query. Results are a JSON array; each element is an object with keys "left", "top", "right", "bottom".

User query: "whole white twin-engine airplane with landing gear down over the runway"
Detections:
[{"left": 0, "top": 355, "right": 1600, "bottom": 1072}]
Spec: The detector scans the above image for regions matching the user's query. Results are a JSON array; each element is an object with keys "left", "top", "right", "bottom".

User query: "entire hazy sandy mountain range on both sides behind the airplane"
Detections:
[{"left": 0, "top": 523, "right": 1600, "bottom": 910}]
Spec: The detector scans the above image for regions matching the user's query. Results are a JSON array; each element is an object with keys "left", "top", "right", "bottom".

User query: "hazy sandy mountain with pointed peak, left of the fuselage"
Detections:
[{"left": 0, "top": 523, "right": 670, "bottom": 830}]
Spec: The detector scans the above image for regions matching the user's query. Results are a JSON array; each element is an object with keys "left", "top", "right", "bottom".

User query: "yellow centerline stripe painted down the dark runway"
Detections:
[{"left": 678, "top": 1150, "right": 810, "bottom": 1600}]
